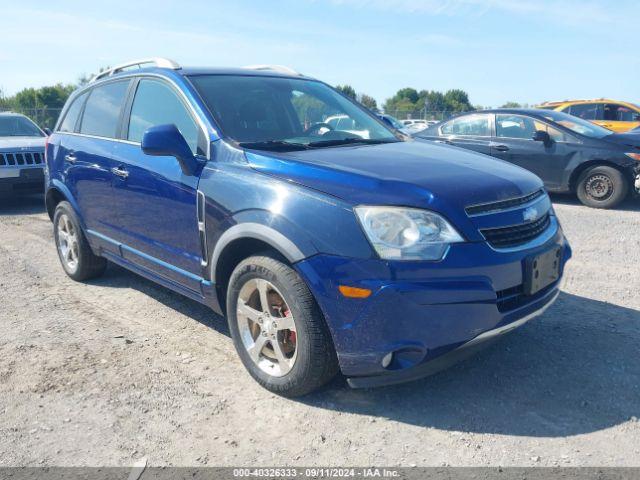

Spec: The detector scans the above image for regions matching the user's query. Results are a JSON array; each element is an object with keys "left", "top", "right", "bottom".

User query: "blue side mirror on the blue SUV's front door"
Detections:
[{"left": 140, "top": 124, "right": 199, "bottom": 175}]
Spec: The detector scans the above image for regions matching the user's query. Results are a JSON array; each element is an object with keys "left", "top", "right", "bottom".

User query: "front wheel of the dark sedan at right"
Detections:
[{"left": 576, "top": 165, "right": 629, "bottom": 208}]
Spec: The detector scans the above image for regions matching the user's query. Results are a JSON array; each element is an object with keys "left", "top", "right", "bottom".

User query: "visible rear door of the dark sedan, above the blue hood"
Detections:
[{"left": 436, "top": 113, "right": 493, "bottom": 155}]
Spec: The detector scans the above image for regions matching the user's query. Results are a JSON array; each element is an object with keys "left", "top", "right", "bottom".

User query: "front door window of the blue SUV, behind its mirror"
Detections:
[{"left": 127, "top": 79, "right": 199, "bottom": 154}]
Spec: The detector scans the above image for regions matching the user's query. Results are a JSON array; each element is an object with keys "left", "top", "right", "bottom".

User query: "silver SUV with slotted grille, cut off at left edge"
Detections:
[{"left": 0, "top": 113, "right": 46, "bottom": 196}]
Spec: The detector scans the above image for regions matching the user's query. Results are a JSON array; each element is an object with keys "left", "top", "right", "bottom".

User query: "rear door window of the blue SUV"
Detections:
[{"left": 80, "top": 80, "right": 129, "bottom": 138}]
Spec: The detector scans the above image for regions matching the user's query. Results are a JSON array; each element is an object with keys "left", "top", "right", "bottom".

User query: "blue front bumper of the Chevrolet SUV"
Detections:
[{"left": 296, "top": 219, "right": 571, "bottom": 387}]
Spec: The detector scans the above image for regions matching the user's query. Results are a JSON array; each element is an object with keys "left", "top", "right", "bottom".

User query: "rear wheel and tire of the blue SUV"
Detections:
[{"left": 53, "top": 201, "right": 107, "bottom": 282}]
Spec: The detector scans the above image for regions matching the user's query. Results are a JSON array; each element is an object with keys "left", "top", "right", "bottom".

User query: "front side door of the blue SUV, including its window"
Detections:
[{"left": 108, "top": 77, "right": 207, "bottom": 290}]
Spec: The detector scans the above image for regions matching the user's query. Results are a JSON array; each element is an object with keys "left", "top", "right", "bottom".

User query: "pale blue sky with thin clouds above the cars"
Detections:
[{"left": 0, "top": 0, "right": 640, "bottom": 107}]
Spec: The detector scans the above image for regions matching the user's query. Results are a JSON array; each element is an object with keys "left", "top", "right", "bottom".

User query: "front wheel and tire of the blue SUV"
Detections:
[{"left": 226, "top": 256, "right": 338, "bottom": 397}]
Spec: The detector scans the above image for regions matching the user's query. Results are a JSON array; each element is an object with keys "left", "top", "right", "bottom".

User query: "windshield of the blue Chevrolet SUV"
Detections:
[{"left": 191, "top": 75, "right": 399, "bottom": 149}]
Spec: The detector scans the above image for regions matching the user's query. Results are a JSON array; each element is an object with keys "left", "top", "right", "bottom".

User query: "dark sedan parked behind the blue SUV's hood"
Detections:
[{"left": 416, "top": 109, "right": 640, "bottom": 208}]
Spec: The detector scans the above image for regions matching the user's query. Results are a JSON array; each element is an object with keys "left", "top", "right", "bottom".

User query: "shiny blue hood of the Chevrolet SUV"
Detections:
[{"left": 246, "top": 141, "right": 542, "bottom": 211}]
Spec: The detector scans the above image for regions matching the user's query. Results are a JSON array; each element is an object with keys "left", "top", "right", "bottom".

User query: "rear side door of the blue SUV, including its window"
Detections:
[{"left": 58, "top": 80, "right": 130, "bottom": 248}]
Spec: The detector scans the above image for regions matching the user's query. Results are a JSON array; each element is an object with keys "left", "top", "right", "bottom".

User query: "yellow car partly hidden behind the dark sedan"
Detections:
[{"left": 538, "top": 98, "right": 640, "bottom": 132}]
